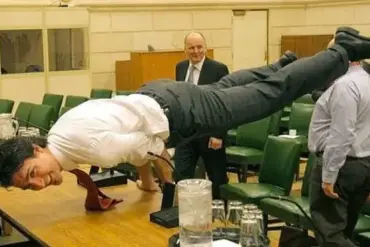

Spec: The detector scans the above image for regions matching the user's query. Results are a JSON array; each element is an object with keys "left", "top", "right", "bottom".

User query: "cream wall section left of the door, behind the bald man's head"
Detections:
[{"left": 90, "top": 10, "right": 233, "bottom": 89}]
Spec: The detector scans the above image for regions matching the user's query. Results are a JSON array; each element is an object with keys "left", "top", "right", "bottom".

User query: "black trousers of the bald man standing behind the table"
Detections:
[{"left": 174, "top": 136, "right": 228, "bottom": 199}]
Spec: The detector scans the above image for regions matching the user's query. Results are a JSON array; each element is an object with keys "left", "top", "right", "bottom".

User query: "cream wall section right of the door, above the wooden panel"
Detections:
[{"left": 269, "top": 3, "right": 370, "bottom": 61}]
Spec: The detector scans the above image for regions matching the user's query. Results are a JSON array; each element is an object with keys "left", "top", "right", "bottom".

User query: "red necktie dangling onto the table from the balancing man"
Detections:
[{"left": 69, "top": 169, "right": 123, "bottom": 211}]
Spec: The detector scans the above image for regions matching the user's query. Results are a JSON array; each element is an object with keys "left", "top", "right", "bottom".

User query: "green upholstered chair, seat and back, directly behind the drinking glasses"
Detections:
[{"left": 220, "top": 135, "right": 300, "bottom": 205}]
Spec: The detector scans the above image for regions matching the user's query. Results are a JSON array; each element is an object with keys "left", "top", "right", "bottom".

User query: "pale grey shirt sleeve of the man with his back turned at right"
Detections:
[{"left": 322, "top": 81, "right": 359, "bottom": 184}]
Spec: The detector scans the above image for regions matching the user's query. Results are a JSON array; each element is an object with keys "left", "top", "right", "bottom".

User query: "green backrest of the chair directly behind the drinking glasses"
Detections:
[{"left": 258, "top": 135, "right": 301, "bottom": 195}]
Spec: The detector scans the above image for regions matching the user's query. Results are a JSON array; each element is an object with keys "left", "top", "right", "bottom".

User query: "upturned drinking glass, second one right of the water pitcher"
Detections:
[{"left": 226, "top": 201, "right": 243, "bottom": 238}]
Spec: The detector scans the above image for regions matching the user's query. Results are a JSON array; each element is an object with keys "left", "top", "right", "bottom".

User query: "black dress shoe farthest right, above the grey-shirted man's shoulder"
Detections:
[{"left": 335, "top": 27, "right": 370, "bottom": 61}]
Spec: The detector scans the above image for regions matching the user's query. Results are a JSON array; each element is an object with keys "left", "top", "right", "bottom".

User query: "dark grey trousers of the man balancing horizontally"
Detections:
[{"left": 138, "top": 45, "right": 348, "bottom": 146}]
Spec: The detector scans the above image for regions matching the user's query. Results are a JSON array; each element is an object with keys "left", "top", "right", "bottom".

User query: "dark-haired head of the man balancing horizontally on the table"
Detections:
[{"left": 0, "top": 136, "right": 63, "bottom": 190}]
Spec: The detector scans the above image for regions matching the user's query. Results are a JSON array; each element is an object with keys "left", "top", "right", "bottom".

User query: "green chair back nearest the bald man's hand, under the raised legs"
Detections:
[{"left": 236, "top": 116, "right": 271, "bottom": 149}]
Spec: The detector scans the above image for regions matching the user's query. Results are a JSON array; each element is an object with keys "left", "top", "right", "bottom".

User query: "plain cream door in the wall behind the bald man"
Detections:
[{"left": 233, "top": 10, "right": 268, "bottom": 71}]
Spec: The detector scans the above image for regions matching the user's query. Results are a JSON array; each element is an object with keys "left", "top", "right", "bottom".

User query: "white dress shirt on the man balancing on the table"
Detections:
[{"left": 48, "top": 94, "right": 169, "bottom": 170}]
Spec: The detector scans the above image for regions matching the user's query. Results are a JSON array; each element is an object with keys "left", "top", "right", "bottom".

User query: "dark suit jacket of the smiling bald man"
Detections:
[{"left": 176, "top": 57, "right": 229, "bottom": 139}]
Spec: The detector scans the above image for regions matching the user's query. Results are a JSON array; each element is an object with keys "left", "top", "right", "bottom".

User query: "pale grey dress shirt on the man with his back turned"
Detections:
[{"left": 308, "top": 65, "right": 370, "bottom": 184}]
